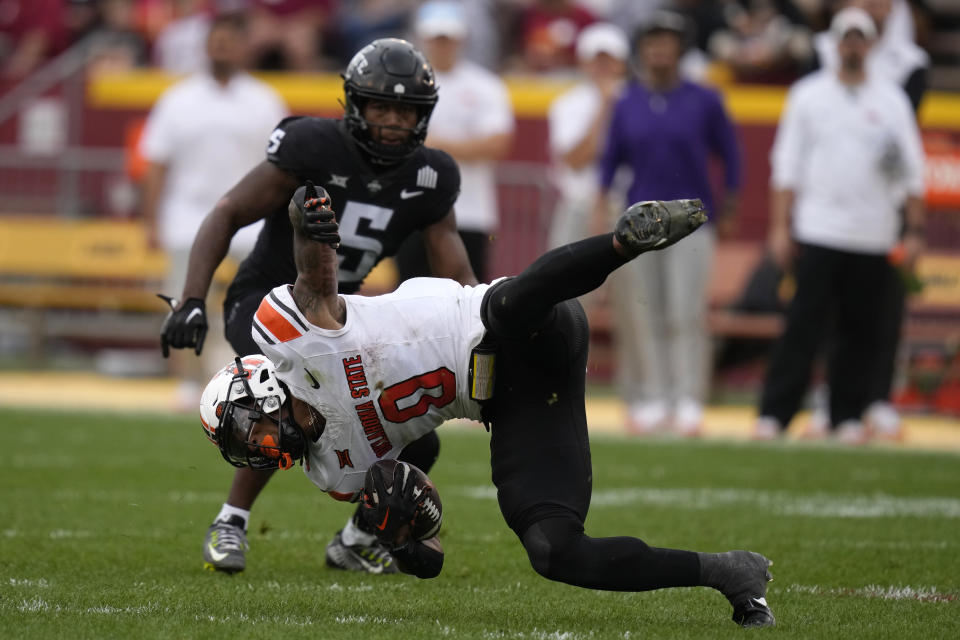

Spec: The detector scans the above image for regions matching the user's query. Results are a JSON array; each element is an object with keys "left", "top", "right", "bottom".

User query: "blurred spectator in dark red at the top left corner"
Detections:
[{"left": 0, "top": 0, "right": 68, "bottom": 80}]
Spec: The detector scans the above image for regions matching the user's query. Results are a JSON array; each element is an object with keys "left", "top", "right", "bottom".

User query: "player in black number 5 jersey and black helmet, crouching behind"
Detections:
[{"left": 161, "top": 38, "right": 476, "bottom": 573}]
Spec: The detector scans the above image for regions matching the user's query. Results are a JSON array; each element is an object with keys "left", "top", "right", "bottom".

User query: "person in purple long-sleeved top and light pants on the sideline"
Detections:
[{"left": 593, "top": 11, "right": 740, "bottom": 437}]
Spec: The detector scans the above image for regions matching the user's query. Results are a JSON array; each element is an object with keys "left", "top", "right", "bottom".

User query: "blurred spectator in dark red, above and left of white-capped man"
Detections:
[{"left": 519, "top": 0, "right": 596, "bottom": 72}]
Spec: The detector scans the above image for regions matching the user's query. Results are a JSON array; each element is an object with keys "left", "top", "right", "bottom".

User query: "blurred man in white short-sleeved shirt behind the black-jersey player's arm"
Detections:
[{"left": 140, "top": 14, "right": 286, "bottom": 410}]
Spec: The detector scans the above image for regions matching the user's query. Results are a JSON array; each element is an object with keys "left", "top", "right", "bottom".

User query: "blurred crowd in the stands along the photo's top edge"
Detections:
[{"left": 0, "top": 0, "right": 960, "bottom": 88}]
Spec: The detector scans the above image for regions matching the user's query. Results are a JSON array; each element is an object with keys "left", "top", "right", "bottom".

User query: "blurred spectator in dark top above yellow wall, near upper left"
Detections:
[{"left": 83, "top": 0, "right": 149, "bottom": 73}]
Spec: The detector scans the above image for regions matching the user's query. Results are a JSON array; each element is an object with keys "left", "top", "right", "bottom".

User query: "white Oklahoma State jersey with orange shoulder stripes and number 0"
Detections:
[{"left": 252, "top": 278, "right": 489, "bottom": 500}]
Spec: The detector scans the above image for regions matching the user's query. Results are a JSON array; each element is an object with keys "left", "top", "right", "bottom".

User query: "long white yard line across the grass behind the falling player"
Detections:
[{"left": 451, "top": 486, "right": 960, "bottom": 519}]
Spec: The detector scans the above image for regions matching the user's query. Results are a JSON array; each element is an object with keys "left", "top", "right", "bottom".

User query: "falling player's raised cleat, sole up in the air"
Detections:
[{"left": 614, "top": 200, "right": 707, "bottom": 256}]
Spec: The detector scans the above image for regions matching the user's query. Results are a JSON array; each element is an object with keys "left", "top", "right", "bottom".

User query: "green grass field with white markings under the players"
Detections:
[{"left": 0, "top": 410, "right": 960, "bottom": 640}]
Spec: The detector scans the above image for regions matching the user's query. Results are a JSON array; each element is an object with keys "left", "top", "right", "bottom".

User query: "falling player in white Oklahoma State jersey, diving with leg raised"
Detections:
[{"left": 201, "top": 184, "right": 774, "bottom": 627}]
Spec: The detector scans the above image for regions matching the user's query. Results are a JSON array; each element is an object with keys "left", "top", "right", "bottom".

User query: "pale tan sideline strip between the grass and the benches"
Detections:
[{"left": 0, "top": 372, "right": 960, "bottom": 452}]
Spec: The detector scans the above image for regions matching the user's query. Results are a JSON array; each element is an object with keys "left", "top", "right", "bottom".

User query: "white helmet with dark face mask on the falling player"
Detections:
[{"left": 200, "top": 355, "right": 306, "bottom": 469}]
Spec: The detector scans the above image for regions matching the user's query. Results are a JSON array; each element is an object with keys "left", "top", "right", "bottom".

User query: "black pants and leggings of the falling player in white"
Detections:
[{"left": 481, "top": 234, "right": 700, "bottom": 591}]
